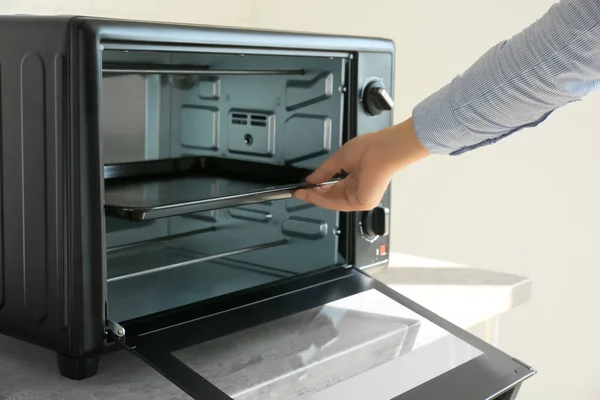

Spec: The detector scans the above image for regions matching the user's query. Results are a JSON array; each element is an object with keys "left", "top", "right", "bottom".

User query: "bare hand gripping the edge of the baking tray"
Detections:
[{"left": 294, "top": 119, "right": 429, "bottom": 211}]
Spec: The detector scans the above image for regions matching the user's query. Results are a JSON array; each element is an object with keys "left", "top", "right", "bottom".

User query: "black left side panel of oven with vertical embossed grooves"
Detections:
[{"left": 0, "top": 16, "right": 76, "bottom": 352}]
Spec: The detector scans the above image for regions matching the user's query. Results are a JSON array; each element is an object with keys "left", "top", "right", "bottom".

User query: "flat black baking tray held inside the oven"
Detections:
[{"left": 104, "top": 157, "right": 347, "bottom": 221}]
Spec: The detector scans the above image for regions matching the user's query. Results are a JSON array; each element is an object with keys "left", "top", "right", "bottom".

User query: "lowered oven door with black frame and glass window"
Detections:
[{"left": 117, "top": 268, "right": 534, "bottom": 400}]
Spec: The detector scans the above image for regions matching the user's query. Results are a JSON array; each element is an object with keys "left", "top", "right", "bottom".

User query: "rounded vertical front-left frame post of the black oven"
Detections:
[{"left": 66, "top": 17, "right": 106, "bottom": 355}]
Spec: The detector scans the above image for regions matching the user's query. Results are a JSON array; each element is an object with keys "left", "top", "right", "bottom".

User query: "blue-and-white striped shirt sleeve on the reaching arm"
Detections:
[{"left": 413, "top": 0, "right": 600, "bottom": 155}]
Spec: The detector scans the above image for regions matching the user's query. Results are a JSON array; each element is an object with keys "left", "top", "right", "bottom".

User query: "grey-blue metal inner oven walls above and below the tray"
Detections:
[{"left": 101, "top": 51, "right": 346, "bottom": 321}]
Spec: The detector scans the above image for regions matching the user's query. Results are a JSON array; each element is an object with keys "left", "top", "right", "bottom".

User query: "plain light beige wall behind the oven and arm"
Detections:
[{"left": 0, "top": 0, "right": 600, "bottom": 400}]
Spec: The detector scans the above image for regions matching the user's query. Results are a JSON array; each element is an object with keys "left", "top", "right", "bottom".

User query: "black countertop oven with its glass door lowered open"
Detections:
[{"left": 0, "top": 16, "right": 534, "bottom": 400}]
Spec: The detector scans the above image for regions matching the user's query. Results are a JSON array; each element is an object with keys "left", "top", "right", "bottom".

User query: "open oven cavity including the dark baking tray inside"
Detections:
[{"left": 100, "top": 48, "right": 349, "bottom": 322}]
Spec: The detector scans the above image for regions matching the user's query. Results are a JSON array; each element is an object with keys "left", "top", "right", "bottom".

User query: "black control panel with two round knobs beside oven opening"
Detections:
[{"left": 354, "top": 52, "right": 394, "bottom": 269}]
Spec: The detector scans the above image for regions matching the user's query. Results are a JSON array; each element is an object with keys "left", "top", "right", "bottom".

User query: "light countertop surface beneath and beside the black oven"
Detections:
[{"left": 0, "top": 253, "right": 531, "bottom": 400}]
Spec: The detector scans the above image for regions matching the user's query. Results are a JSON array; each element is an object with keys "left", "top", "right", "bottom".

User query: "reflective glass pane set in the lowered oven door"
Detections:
[{"left": 174, "top": 290, "right": 481, "bottom": 400}]
